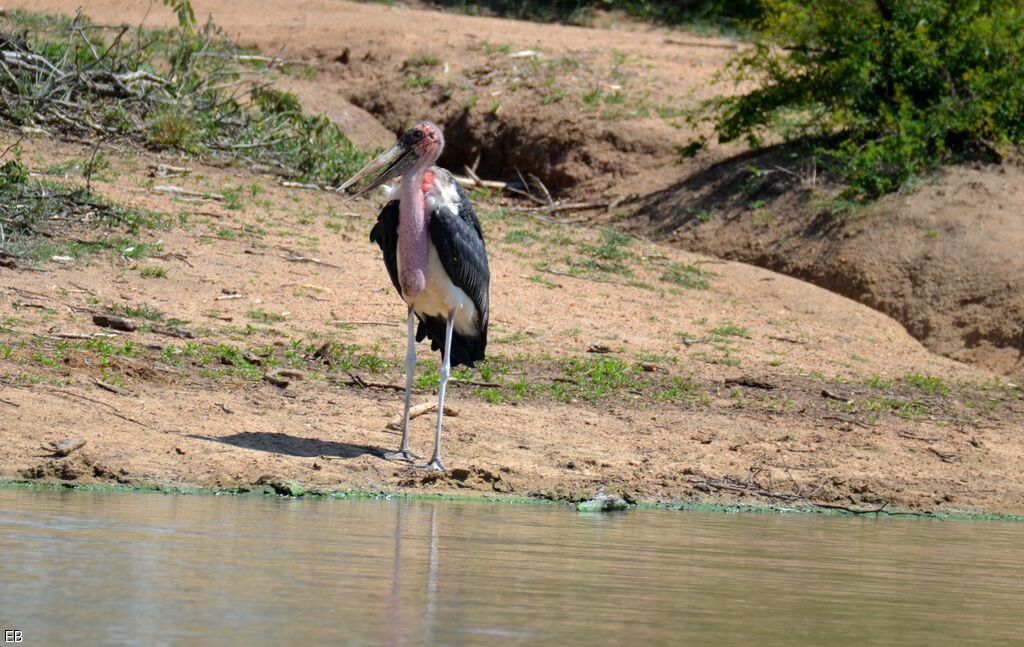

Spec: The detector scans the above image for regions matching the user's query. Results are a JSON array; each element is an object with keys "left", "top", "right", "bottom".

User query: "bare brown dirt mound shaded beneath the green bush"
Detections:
[{"left": 634, "top": 148, "right": 1024, "bottom": 377}]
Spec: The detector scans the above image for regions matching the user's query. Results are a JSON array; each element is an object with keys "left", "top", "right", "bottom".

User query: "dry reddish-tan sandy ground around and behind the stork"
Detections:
[{"left": 0, "top": 0, "right": 1024, "bottom": 514}]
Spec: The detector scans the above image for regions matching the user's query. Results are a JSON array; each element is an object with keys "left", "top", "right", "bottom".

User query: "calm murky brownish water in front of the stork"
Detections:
[{"left": 0, "top": 489, "right": 1024, "bottom": 647}]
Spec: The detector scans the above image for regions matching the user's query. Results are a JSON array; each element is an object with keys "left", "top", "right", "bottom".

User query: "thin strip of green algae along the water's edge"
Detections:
[{"left": 0, "top": 479, "right": 1024, "bottom": 523}]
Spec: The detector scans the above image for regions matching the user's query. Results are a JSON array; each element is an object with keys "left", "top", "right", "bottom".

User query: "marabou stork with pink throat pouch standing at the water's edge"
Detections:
[{"left": 338, "top": 122, "right": 490, "bottom": 471}]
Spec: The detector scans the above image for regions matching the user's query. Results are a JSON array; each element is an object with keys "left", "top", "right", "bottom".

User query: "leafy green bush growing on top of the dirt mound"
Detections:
[{"left": 702, "top": 0, "right": 1024, "bottom": 197}]
